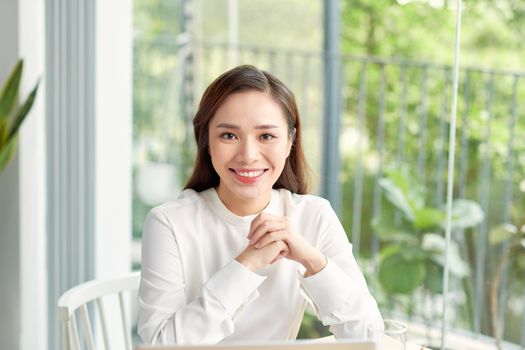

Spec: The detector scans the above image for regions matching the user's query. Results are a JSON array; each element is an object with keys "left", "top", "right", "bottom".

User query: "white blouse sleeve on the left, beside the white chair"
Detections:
[{"left": 138, "top": 209, "right": 265, "bottom": 344}]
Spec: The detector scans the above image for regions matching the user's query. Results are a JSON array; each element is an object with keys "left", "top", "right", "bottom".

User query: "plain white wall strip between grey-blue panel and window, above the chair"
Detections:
[{"left": 95, "top": 0, "right": 133, "bottom": 277}]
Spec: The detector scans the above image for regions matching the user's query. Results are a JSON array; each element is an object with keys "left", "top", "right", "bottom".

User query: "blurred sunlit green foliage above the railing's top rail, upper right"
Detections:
[{"left": 341, "top": 0, "right": 525, "bottom": 69}]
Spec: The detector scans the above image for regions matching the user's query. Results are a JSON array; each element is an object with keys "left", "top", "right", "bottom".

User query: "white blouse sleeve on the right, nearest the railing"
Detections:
[{"left": 300, "top": 203, "right": 382, "bottom": 339}]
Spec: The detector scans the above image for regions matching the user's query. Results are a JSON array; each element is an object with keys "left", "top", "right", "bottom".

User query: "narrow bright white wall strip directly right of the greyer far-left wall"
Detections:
[{"left": 18, "top": 0, "right": 47, "bottom": 350}]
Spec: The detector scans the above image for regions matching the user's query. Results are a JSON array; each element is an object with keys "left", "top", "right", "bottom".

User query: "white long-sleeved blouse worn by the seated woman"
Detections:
[{"left": 138, "top": 188, "right": 382, "bottom": 344}]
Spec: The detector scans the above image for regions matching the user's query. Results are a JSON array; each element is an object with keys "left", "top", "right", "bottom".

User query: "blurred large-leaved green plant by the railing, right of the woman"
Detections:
[{"left": 372, "top": 170, "right": 483, "bottom": 295}]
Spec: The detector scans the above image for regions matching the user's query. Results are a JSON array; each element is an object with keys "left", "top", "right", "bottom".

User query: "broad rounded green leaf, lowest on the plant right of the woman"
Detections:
[{"left": 378, "top": 254, "right": 425, "bottom": 295}]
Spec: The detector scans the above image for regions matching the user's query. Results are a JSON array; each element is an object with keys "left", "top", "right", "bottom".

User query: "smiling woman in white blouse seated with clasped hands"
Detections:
[{"left": 138, "top": 66, "right": 382, "bottom": 344}]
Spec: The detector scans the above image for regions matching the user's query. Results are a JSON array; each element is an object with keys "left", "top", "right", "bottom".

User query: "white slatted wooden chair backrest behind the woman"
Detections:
[{"left": 58, "top": 271, "right": 140, "bottom": 350}]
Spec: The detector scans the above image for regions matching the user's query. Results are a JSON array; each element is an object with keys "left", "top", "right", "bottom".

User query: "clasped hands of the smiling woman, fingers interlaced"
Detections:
[{"left": 237, "top": 212, "right": 326, "bottom": 276}]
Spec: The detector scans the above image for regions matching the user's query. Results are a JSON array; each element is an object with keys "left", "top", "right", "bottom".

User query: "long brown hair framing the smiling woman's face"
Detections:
[{"left": 184, "top": 65, "right": 309, "bottom": 194}]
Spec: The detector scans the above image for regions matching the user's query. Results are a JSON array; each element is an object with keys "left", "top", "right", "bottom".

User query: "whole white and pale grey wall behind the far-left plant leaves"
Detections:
[{"left": 0, "top": 0, "right": 46, "bottom": 349}]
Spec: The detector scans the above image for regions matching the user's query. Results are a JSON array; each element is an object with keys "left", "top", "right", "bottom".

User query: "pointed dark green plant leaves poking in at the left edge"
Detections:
[{"left": 0, "top": 60, "right": 39, "bottom": 172}]
